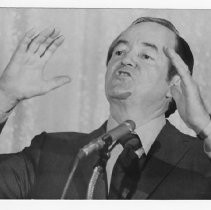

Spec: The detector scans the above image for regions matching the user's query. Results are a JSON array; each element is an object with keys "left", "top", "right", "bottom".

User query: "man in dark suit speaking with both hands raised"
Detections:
[{"left": 0, "top": 17, "right": 211, "bottom": 199}]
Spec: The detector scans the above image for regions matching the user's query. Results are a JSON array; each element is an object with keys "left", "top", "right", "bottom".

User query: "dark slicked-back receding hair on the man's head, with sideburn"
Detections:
[{"left": 106, "top": 17, "right": 194, "bottom": 118}]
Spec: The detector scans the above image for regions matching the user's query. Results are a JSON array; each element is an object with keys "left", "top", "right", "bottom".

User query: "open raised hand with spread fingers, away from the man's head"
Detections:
[{"left": 0, "top": 28, "right": 70, "bottom": 110}]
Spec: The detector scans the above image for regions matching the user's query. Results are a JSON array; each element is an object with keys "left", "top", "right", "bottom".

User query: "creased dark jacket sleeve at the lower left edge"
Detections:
[{"left": 0, "top": 133, "right": 45, "bottom": 199}]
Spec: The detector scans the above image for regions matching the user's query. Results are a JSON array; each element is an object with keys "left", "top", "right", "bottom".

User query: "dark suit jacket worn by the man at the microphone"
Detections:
[{"left": 0, "top": 121, "right": 211, "bottom": 199}]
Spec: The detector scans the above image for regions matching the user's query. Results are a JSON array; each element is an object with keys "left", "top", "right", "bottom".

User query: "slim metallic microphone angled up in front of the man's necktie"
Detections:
[{"left": 78, "top": 120, "right": 136, "bottom": 159}]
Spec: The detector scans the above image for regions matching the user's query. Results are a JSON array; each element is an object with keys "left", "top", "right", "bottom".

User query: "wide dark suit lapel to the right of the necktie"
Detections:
[{"left": 132, "top": 121, "right": 189, "bottom": 199}]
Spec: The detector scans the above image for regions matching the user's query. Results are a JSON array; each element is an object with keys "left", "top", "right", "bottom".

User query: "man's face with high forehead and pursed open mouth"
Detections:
[{"left": 105, "top": 22, "right": 176, "bottom": 109}]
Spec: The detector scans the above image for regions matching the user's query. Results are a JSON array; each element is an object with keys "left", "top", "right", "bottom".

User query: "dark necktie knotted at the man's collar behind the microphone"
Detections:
[{"left": 108, "top": 134, "right": 146, "bottom": 199}]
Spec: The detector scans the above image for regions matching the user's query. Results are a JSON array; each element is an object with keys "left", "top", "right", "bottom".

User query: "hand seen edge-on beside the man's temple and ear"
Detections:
[{"left": 164, "top": 48, "right": 210, "bottom": 133}]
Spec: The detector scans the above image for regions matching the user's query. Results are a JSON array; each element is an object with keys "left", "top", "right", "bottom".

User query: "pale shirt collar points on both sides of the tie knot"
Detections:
[{"left": 107, "top": 115, "right": 166, "bottom": 155}]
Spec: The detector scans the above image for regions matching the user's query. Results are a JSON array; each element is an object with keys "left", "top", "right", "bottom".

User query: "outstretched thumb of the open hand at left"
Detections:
[{"left": 44, "top": 76, "right": 71, "bottom": 92}]
